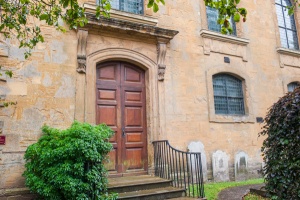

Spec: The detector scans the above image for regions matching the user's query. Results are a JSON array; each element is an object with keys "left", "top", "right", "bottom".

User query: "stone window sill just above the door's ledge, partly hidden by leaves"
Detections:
[{"left": 83, "top": 3, "right": 158, "bottom": 26}]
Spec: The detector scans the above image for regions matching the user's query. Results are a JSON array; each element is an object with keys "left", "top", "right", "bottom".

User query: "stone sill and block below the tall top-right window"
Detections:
[{"left": 277, "top": 48, "right": 300, "bottom": 68}]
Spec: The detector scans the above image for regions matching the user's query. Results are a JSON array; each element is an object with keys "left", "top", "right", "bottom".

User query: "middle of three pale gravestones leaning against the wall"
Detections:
[{"left": 212, "top": 150, "right": 229, "bottom": 182}]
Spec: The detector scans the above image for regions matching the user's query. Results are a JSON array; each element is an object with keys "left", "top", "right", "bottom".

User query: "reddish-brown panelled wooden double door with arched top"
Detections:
[{"left": 96, "top": 62, "right": 148, "bottom": 175}]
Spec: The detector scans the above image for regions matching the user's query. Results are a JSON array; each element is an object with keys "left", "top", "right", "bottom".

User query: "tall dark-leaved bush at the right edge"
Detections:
[{"left": 260, "top": 87, "right": 300, "bottom": 200}]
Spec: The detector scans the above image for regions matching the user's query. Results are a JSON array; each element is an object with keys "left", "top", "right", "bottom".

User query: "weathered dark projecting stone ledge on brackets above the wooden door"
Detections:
[{"left": 85, "top": 14, "right": 178, "bottom": 40}]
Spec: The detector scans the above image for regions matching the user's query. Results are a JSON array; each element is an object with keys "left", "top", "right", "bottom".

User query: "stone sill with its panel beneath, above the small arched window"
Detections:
[{"left": 200, "top": 30, "right": 249, "bottom": 62}]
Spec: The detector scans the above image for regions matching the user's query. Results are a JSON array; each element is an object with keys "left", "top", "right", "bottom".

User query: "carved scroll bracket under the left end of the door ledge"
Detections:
[{"left": 77, "top": 30, "right": 88, "bottom": 73}]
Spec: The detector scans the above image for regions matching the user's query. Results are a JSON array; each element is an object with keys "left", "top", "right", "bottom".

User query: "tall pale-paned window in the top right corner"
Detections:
[{"left": 275, "top": 0, "right": 299, "bottom": 49}]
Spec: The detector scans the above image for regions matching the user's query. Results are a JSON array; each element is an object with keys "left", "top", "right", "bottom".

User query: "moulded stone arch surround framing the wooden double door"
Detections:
[{"left": 75, "top": 48, "right": 163, "bottom": 144}]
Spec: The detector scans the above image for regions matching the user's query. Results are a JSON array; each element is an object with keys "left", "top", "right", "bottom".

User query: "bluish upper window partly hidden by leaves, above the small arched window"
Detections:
[{"left": 206, "top": 6, "right": 236, "bottom": 35}]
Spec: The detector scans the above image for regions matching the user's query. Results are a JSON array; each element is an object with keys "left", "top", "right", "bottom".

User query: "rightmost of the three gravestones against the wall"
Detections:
[{"left": 234, "top": 151, "right": 248, "bottom": 181}]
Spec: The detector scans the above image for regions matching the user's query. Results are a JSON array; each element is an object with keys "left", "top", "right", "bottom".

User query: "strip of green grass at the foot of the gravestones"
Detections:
[{"left": 204, "top": 178, "right": 264, "bottom": 200}]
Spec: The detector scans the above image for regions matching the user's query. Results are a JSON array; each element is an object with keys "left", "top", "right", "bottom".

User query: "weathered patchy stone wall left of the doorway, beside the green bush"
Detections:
[{"left": 0, "top": 26, "right": 77, "bottom": 188}]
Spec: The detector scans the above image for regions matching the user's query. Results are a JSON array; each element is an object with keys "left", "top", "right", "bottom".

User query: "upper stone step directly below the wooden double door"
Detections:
[{"left": 108, "top": 175, "right": 172, "bottom": 193}]
